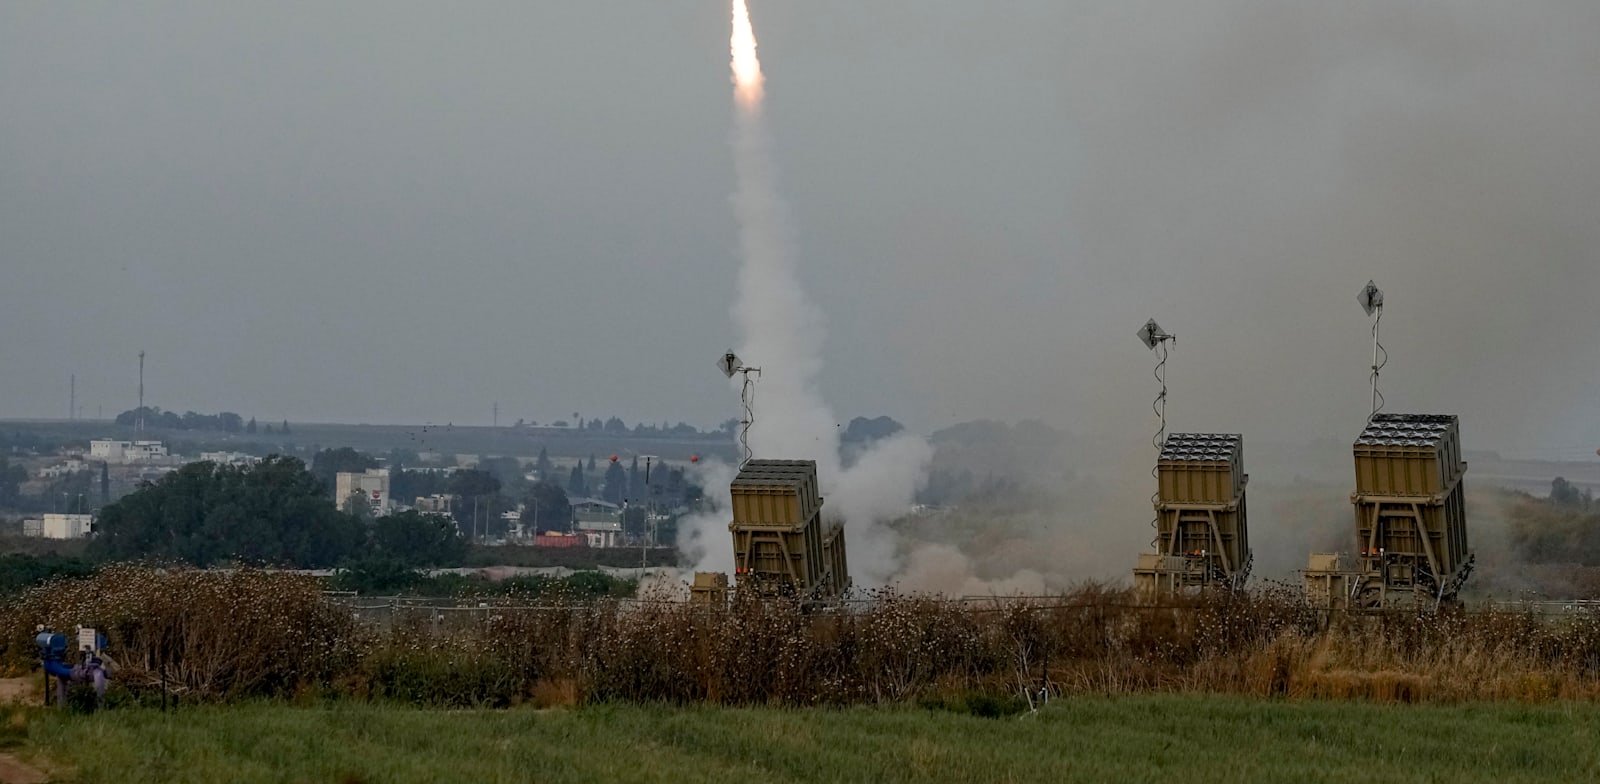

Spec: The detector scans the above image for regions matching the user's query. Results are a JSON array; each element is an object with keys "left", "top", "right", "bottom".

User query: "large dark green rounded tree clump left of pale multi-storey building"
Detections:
[{"left": 90, "top": 456, "right": 362, "bottom": 568}]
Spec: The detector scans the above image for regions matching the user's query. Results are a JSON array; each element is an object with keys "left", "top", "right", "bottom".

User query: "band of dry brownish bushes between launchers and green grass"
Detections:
[{"left": 0, "top": 566, "right": 1600, "bottom": 715}]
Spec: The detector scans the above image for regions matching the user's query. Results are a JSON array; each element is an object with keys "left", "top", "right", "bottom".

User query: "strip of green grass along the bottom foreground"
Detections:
[{"left": 13, "top": 696, "right": 1600, "bottom": 784}]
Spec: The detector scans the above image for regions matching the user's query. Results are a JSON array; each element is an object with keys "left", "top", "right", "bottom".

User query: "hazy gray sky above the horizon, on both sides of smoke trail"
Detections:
[{"left": 0, "top": 0, "right": 1600, "bottom": 456}]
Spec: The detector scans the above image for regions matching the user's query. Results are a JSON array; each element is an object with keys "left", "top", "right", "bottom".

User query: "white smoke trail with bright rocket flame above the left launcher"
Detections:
[{"left": 683, "top": 0, "right": 933, "bottom": 586}]
